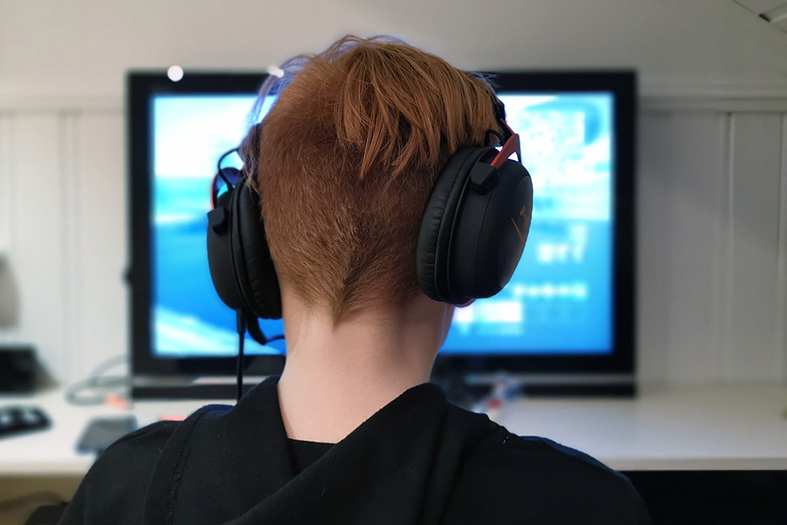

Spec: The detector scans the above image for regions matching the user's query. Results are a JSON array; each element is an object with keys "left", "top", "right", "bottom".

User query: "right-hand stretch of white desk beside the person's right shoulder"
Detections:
[{"left": 496, "top": 385, "right": 787, "bottom": 470}]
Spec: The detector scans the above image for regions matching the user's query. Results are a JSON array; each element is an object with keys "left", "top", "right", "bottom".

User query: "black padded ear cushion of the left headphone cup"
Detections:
[{"left": 231, "top": 180, "right": 282, "bottom": 319}]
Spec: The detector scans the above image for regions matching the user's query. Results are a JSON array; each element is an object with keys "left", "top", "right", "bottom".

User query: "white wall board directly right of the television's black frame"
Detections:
[{"left": 638, "top": 112, "right": 727, "bottom": 382}]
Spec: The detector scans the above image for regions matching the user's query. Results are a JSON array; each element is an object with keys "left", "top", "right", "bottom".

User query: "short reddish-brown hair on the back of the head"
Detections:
[{"left": 258, "top": 37, "right": 497, "bottom": 323}]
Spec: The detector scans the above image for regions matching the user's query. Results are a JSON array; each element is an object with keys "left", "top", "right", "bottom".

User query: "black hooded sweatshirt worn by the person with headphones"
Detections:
[{"left": 61, "top": 378, "right": 650, "bottom": 525}]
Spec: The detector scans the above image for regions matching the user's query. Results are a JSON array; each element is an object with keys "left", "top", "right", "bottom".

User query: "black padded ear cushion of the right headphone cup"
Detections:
[{"left": 415, "top": 147, "right": 495, "bottom": 302}]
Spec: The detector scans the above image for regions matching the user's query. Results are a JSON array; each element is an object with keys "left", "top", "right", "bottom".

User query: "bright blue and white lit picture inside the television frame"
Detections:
[{"left": 150, "top": 92, "right": 615, "bottom": 358}]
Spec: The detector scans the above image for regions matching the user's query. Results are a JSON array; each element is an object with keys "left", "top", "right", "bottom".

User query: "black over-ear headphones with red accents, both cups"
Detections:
[{"left": 208, "top": 96, "right": 533, "bottom": 327}]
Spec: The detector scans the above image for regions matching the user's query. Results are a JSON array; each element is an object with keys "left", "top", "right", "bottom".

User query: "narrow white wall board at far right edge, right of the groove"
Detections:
[{"left": 724, "top": 113, "right": 784, "bottom": 381}]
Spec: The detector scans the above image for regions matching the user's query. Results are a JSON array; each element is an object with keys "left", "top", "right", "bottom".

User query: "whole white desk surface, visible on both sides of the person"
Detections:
[{"left": 0, "top": 386, "right": 787, "bottom": 478}]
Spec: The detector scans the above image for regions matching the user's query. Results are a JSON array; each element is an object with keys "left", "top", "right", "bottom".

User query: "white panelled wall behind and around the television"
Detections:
[{"left": 0, "top": 0, "right": 787, "bottom": 383}]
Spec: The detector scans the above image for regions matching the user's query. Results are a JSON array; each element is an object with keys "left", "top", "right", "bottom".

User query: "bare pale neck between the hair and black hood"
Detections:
[{"left": 279, "top": 290, "right": 453, "bottom": 443}]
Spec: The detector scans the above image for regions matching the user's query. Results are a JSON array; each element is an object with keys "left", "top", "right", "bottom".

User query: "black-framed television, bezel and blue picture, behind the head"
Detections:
[{"left": 128, "top": 71, "right": 636, "bottom": 381}]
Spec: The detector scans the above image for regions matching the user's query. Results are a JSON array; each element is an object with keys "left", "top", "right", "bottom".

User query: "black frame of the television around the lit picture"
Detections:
[{"left": 126, "top": 70, "right": 637, "bottom": 377}]
